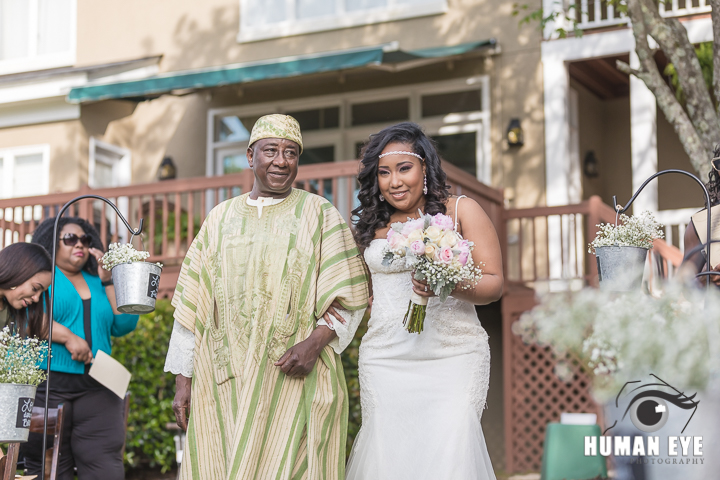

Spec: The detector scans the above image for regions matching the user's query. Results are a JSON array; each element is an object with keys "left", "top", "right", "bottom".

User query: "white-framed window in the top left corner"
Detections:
[{"left": 0, "top": 0, "right": 76, "bottom": 74}]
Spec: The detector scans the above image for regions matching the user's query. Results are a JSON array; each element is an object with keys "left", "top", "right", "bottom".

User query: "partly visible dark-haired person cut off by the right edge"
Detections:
[{"left": 679, "top": 149, "right": 720, "bottom": 287}]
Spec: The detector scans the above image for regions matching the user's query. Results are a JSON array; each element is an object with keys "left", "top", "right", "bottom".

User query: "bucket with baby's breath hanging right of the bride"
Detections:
[{"left": 588, "top": 212, "right": 664, "bottom": 292}]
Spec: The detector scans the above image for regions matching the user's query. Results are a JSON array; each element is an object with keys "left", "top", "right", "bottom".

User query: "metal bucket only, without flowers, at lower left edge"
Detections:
[{"left": 0, "top": 383, "right": 37, "bottom": 443}]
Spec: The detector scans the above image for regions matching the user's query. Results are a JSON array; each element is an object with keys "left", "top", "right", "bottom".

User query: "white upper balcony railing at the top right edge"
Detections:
[{"left": 543, "top": 0, "right": 711, "bottom": 30}]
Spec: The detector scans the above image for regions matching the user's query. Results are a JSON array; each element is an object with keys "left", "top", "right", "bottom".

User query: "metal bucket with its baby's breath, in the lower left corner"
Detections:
[{"left": 0, "top": 327, "right": 47, "bottom": 443}]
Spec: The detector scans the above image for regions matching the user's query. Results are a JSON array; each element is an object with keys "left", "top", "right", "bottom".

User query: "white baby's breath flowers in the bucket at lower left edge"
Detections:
[{"left": 0, "top": 327, "right": 48, "bottom": 386}]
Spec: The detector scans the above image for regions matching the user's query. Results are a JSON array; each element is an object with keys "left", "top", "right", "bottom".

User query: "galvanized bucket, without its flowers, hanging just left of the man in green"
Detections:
[{"left": 112, "top": 262, "right": 162, "bottom": 315}]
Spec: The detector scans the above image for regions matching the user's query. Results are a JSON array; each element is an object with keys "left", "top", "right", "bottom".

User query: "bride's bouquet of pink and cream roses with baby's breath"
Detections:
[{"left": 383, "top": 213, "right": 482, "bottom": 333}]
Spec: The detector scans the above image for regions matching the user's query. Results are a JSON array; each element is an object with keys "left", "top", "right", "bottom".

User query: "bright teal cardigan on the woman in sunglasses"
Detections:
[{"left": 41, "top": 267, "right": 140, "bottom": 374}]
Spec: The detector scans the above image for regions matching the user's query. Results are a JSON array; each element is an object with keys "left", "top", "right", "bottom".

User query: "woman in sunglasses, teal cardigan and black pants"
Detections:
[{"left": 21, "top": 217, "right": 138, "bottom": 480}]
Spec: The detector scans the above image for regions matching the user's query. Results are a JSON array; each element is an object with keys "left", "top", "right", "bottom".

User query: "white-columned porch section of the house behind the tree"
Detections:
[{"left": 541, "top": 0, "right": 712, "bottom": 248}]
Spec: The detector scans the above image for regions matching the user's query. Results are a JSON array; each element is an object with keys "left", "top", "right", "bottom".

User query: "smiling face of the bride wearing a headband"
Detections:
[{"left": 378, "top": 143, "right": 425, "bottom": 213}]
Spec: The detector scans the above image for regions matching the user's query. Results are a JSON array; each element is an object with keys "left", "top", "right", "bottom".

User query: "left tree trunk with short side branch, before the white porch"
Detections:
[{"left": 618, "top": 0, "right": 708, "bottom": 175}]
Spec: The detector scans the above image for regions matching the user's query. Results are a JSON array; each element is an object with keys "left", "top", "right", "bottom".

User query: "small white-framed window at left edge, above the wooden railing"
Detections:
[{"left": 0, "top": 145, "right": 50, "bottom": 198}]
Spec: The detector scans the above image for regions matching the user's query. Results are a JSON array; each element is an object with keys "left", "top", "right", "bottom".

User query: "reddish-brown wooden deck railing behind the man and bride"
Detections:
[{"left": 0, "top": 160, "right": 503, "bottom": 280}]
